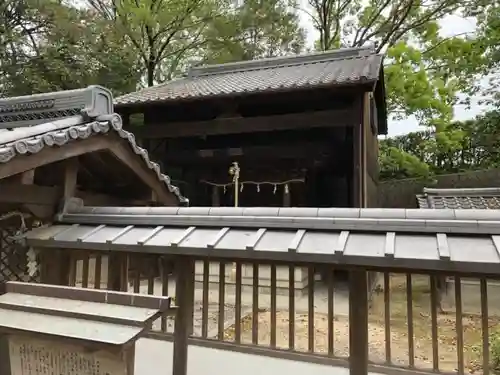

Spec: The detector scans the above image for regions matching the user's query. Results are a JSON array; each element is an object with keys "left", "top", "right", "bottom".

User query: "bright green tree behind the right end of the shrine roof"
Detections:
[{"left": 308, "top": 0, "right": 487, "bottom": 128}]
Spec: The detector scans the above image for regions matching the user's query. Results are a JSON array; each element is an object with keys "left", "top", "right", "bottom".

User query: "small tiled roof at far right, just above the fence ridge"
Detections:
[{"left": 417, "top": 188, "right": 500, "bottom": 210}]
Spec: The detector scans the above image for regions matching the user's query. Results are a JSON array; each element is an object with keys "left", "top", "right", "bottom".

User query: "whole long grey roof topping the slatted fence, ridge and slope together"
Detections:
[{"left": 26, "top": 204, "right": 500, "bottom": 274}]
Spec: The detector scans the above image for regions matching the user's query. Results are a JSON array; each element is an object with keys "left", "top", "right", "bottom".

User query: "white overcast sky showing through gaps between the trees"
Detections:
[{"left": 300, "top": 7, "right": 487, "bottom": 136}]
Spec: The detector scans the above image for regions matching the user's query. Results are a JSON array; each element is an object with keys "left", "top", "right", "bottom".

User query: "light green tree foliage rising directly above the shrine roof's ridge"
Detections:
[{"left": 88, "top": 0, "right": 305, "bottom": 86}]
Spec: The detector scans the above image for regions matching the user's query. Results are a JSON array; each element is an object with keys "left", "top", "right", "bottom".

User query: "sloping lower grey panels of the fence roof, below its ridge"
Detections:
[{"left": 26, "top": 219, "right": 500, "bottom": 275}]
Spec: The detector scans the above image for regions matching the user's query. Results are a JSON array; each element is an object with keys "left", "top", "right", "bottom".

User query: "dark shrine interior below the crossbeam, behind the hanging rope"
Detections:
[{"left": 164, "top": 127, "right": 353, "bottom": 207}]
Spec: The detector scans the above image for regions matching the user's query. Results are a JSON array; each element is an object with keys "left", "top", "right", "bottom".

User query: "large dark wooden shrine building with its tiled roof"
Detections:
[{"left": 115, "top": 48, "right": 387, "bottom": 207}]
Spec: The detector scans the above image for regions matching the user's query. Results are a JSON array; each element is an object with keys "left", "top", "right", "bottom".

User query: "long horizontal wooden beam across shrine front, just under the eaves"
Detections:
[{"left": 127, "top": 109, "right": 360, "bottom": 139}]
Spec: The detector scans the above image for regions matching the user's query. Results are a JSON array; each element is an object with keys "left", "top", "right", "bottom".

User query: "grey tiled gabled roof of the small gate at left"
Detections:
[{"left": 0, "top": 114, "right": 186, "bottom": 202}]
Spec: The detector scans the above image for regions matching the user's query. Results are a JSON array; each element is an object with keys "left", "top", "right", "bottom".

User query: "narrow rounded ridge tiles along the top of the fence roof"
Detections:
[{"left": 53, "top": 198, "right": 500, "bottom": 234}]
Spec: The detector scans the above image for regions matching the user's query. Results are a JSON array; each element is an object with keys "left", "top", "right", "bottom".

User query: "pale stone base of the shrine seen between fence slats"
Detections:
[{"left": 195, "top": 262, "right": 308, "bottom": 294}]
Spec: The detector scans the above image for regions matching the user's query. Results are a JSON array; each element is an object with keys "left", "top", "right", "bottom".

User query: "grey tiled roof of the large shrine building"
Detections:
[{"left": 115, "top": 47, "right": 383, "bottom": 106}]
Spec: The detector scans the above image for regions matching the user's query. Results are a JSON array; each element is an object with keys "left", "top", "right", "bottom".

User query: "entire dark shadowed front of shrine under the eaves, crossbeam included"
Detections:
[{"left": 125, "top": 87, "right": 368, "bottom": 207}]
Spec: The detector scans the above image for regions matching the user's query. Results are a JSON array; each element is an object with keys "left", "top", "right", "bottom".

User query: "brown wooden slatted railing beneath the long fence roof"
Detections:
[{"left": 49, "top": 251, "right": 500, "bottom": 374}]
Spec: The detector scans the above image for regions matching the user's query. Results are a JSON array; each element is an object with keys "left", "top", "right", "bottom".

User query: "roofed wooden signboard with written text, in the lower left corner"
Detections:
[{"left": 0, "top": 282, "right": 170, "bottom": 375}]
